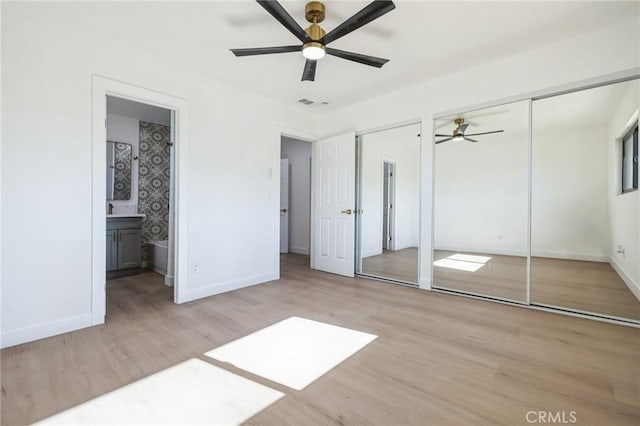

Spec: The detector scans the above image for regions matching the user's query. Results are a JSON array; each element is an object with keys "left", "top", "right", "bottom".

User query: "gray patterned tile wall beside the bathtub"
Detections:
[{"left": 138, "top": 121, "right": 171, "bottom": 260}]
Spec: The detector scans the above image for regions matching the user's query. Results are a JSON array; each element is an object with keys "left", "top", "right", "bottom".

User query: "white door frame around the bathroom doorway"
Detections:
[{"left": 91, "top": 74, "right": 189, "bottom": 325}]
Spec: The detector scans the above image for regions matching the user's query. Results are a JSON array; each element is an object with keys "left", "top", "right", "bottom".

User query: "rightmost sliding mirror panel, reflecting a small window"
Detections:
[{"left": 531, "top": 80, "right": 640, "bottom": 321}]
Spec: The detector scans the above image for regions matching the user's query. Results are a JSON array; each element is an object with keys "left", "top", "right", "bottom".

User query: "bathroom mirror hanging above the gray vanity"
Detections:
[{"left": 107, "top": 141, "right": 132, "bottom": 201}]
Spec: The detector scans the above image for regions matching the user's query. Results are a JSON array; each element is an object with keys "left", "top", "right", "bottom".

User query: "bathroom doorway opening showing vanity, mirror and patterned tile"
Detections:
[{"left": 106, "top": 95, "right": 175, "bottom": 316}]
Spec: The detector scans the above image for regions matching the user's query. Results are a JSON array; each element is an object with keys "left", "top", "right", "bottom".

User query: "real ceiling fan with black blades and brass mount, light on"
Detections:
[{"left": 230, "top": 0, "right": 396, "bottom": 81}]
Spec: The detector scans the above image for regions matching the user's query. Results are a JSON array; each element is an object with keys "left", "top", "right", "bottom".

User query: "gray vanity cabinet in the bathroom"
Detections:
[{"left": 107, "top": 217, "right": 142, "bottom": 278}]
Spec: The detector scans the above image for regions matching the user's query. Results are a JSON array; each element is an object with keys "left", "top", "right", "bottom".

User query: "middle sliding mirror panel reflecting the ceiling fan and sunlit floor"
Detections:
[{"left": 433, "top": 101, "right": 529, "bottom": 303}]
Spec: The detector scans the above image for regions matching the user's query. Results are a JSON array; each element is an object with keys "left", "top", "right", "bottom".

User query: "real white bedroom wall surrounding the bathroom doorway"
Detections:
[{"left": 1, "top": 2, "right": 313, "bottom": 346}]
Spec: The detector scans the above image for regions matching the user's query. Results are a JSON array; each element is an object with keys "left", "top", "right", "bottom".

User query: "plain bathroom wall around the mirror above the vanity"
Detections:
[{"left": 107, "top": 114, "right": 140, "bottom": 214}]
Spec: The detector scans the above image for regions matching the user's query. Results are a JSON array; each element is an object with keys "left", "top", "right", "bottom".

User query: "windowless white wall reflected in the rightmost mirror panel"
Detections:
[{"left": 531, "top": 125, "right": 609, "bottom": 262}]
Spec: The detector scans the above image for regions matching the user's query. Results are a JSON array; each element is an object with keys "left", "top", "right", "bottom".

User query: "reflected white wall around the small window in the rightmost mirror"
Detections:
[{"left": 607, "top": 80, "right": 640, "bottom": 299}]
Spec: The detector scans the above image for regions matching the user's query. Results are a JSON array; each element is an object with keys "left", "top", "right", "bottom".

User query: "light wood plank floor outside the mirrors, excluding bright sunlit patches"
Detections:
[{"left": 1, "top": 255, "right": 640, "bottom": 426}]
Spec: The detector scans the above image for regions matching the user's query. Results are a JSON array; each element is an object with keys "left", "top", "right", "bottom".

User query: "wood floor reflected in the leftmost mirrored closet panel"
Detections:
[{"left": 362, "top": 247, "right": 418, "bottom": 283}]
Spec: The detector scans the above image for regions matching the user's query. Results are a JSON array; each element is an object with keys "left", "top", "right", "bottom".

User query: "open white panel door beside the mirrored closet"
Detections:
[{"left": 311, "top": 132, "right": 356, "bottom": 277}]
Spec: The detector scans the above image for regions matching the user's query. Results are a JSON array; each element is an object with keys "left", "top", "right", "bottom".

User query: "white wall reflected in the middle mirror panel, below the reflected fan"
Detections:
[{"left": 434, "top": 102, "right": 528, "bottom": 256}]
